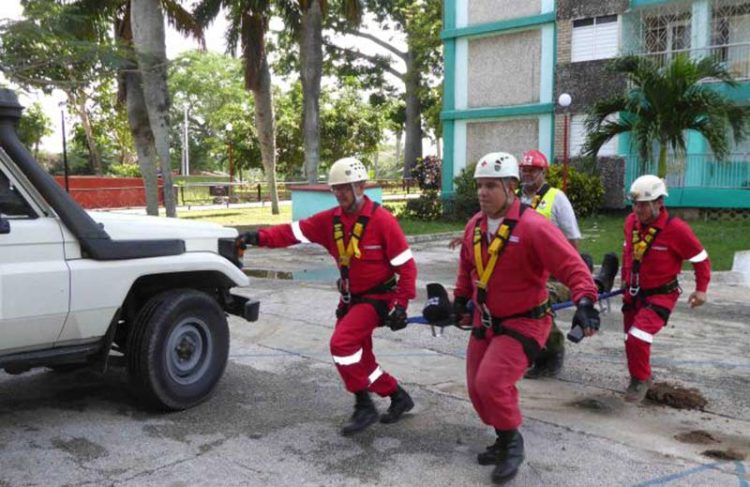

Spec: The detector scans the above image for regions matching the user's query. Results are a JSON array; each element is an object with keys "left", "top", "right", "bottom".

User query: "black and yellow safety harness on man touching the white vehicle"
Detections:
[{"left": 333, "top": 203, "right": 397, "bottom": 321}]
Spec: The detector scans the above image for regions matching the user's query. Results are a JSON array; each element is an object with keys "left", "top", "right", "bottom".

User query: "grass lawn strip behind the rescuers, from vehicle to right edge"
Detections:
[{"left": 178, "top": 206, "right": 750, "bottom": 271}]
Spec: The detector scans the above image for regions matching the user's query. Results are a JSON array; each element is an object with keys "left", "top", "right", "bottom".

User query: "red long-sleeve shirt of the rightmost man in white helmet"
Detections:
[{"left": 622, "top": 208, "right": 711, "bottom": 292}]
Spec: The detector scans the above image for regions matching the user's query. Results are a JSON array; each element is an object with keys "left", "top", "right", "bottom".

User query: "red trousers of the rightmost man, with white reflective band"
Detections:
[{"left": 622, "top": 301, "right": 665, "bottom": 381}]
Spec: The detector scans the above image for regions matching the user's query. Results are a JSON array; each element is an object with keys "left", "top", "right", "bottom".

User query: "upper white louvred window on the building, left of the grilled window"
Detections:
[{"left": 570, "top": 15, "right": 619, "bottom": 63}]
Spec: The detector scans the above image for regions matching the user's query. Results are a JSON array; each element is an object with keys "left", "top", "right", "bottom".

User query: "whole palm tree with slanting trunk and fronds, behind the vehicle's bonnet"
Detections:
[{"left": 194, "top": 0, "right": 279, "bottom": 215}]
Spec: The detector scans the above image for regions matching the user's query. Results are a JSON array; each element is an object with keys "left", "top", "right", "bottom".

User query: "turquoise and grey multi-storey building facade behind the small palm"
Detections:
[{"left": 442, "top": 0, "right": 750, "bottom": 208}]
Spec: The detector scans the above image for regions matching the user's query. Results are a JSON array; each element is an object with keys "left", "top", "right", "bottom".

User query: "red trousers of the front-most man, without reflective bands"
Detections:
[{"left": 466, "top": 318, "right": 552, "bottom": 430}]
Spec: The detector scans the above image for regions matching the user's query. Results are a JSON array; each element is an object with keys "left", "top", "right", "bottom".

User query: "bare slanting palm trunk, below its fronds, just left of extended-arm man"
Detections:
[{"left": 253, "top": 57, "right": 279, "bottom": 215}]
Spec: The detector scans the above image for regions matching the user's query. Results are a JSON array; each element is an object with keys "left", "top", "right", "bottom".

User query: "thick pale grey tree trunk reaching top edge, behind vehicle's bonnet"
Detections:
[{"left": 131, "top": 0, "right": 177, "bottom": 217}]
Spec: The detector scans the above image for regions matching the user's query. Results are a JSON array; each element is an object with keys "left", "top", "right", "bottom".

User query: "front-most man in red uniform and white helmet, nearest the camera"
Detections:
[{"left": 454, "top": 152, "right": 599, "bottom": 484}]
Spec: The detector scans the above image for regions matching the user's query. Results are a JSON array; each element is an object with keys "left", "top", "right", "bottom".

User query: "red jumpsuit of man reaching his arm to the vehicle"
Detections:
[{"left": 259, "top": 196, "right": 417, "bottom": 396}]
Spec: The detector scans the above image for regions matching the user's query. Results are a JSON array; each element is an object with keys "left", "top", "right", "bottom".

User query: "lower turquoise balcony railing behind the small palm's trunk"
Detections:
[{"left": 625, "top": 153, "right": 750, "bottom": 190}]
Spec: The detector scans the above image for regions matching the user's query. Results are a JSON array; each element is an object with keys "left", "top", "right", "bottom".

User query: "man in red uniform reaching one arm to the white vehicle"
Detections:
[{"left": 238, "top": 158, "right": 417, "bottom": 436}]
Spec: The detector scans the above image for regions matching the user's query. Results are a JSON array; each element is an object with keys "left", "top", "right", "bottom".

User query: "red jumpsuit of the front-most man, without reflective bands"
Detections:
[{"left": 455, "top": 199, "right": 597, "bottom": 430}]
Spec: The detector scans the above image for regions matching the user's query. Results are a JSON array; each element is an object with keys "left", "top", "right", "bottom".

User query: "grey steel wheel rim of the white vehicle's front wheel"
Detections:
[{"left": 166, "top": 317, "right": 213, "bottom": 385}]
